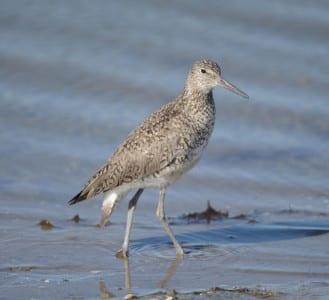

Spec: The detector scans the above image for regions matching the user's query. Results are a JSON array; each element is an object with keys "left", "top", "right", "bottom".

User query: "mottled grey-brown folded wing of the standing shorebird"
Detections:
[{"left": 70, "top": 102, "right": 185, "bottom": 204}]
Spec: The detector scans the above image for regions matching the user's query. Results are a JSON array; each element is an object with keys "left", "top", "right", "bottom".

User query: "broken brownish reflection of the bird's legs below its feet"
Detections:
[{"left": 99, "top": 256, "right": 183, "bottom": 299}]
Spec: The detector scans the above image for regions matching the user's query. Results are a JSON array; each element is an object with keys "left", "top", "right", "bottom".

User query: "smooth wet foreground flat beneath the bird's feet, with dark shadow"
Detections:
[{"left": 0, "top": 205, "right": 329, "bottom": 299}]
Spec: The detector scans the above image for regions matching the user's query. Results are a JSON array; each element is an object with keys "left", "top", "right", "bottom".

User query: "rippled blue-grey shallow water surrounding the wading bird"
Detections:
[{"left": 0, "top": 1, "right": 329, "bottom": 299}]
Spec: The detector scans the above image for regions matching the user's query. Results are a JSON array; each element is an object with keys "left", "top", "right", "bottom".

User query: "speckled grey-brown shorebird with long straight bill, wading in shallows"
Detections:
[{"left": 69, "top": 60, "right": 249, "bottom": 258}]
